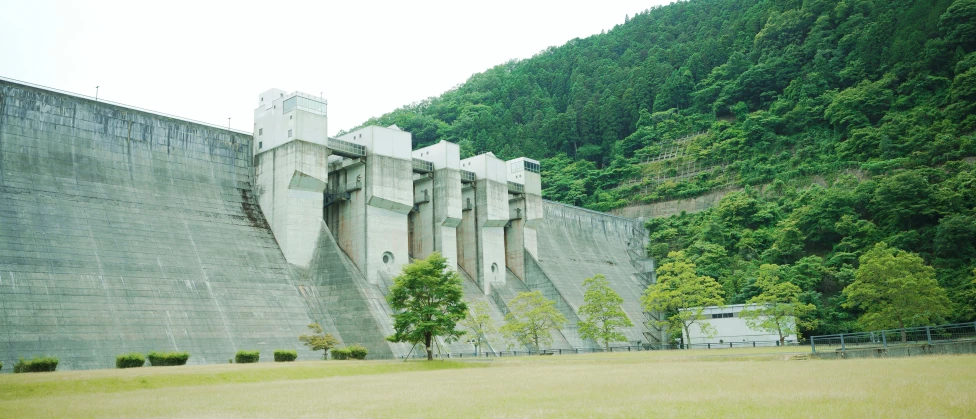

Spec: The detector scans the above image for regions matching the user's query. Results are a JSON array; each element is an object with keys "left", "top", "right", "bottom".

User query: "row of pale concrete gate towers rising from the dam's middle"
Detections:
[{"left": 254, "top": 89, "right": 543, "bottom": 295}]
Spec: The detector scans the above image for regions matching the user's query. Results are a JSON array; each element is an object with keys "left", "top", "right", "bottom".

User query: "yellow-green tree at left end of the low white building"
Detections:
[{"left": 641, "top": 252, "right": 725, "bottom": 343}]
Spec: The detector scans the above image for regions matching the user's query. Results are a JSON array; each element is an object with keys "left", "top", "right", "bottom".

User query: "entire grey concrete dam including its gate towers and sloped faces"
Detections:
[{"left": 0, "top": 80, "right": 661, "bottom": 371}]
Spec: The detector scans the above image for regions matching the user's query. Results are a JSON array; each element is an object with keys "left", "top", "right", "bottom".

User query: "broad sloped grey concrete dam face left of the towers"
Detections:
[{"left": 0, "top": 82, "right": 340, "bottom": 369}]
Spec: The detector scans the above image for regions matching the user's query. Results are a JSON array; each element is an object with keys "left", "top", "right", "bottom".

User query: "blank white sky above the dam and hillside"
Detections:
[{"left": 0, "top": 0, "right": 671, "bottom": 135}]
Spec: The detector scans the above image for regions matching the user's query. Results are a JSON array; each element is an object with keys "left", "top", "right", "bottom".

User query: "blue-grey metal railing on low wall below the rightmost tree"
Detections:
[{"left": 810, "top": 322, "right": 976, "bottom": 352}]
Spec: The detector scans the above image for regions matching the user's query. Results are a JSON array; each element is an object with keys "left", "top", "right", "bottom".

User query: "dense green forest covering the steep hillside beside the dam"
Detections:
[{"left": 354, "top": 0, "right": 976, "bottom": 334}]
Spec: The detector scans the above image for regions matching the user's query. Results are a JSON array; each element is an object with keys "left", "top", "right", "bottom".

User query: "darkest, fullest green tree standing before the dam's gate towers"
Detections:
[{"left": 386, "top": 252, "right": 468, "bottom": 361}]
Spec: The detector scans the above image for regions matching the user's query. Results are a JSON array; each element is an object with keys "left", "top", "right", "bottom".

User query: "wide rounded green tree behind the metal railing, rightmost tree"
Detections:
[{"left": 843, "top": 242, "right": 951, "bottom": 341}]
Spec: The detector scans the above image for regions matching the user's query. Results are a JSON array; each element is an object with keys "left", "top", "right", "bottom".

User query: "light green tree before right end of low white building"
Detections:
[{"left": 742, "top": 265, "right": 817, "bottom": 345}]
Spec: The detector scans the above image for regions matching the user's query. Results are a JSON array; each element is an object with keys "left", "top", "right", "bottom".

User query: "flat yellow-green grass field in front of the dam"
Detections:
[{"left": 0, "top": 348, "right": 976, "bottom": 418}]
